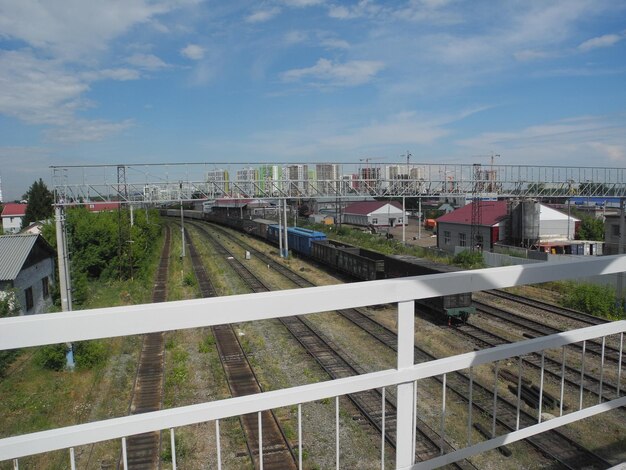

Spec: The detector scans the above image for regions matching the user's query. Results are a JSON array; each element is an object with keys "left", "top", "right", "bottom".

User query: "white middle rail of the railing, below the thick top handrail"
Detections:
[{"left": 0, "top": 320, "right": 626, "bottom": 460}]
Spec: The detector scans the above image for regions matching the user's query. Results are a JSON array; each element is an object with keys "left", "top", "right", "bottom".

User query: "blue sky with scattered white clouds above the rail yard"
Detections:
[{"left": 0, "top": 0, "right": 626, "bottom": 201}]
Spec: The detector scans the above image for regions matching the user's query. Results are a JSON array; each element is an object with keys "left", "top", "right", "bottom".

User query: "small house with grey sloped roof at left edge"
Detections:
[{"left": 0, "top": 235, "right": 56, "bottom": 315}]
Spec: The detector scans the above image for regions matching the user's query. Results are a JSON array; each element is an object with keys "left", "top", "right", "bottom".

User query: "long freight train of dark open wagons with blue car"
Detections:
[{"left": 165, "top": 209, "right": 475, "bottom": 323}]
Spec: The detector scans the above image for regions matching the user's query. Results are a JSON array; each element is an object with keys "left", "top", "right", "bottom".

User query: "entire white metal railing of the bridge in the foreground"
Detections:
[{"left": 0, "top": 256, "right": 626, "bottom": 468}]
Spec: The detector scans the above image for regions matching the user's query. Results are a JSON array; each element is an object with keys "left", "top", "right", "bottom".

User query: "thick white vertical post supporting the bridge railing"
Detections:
[{"left": 396, "top": 300, "right": 415, "bottom": 468}]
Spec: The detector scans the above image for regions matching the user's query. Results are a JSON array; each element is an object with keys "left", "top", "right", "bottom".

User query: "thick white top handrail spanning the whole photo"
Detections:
[{"left": 0, "top": 255, "right": 626, "bottom": 350}]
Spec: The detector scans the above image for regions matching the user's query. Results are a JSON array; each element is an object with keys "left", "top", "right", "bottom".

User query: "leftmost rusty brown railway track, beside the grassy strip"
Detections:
[{"left": 122, "top": 226, "right": 170, "bottom": 470}]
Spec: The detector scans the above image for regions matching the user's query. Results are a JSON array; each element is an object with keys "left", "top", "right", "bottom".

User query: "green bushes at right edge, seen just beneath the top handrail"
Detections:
[{"left": 562, "top": 282, "right": 624, "bottom": 320}]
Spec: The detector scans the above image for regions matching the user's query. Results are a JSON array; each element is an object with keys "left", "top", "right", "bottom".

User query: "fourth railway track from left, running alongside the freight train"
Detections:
[{"left": 202, "top": 221, "right": 610, "bottom": 469}]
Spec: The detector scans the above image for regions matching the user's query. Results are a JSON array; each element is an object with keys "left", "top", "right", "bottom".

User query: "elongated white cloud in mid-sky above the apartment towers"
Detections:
[{"left": 282, "top": 59, "right": 384, "bottom": 86}]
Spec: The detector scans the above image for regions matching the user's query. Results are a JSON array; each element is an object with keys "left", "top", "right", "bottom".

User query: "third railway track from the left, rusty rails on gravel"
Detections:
[{"left": 194, "top": 224, "right": 475, "bottom": 469}]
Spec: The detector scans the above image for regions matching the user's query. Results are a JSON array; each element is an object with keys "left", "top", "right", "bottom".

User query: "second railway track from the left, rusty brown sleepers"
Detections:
[{"left": 185, "top": 226, "right": 297, "bottom": 470}]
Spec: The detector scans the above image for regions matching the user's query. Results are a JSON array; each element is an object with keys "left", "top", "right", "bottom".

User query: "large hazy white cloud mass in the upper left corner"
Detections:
[{"left": 0, "top": 0, "right": 196, "bottom": 142}]
